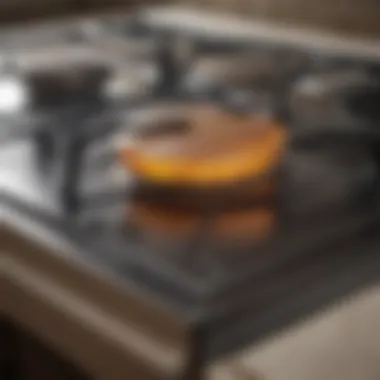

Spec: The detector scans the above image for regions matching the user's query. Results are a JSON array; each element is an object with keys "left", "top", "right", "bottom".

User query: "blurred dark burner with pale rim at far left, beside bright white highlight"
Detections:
[{"left": 0, "top": 44, "right": 159, "bottom": 140}]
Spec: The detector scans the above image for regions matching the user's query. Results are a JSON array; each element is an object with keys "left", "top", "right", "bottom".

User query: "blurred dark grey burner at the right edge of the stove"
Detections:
[{"left": 290, "top": 69, "right": 380, "bottom": 133}]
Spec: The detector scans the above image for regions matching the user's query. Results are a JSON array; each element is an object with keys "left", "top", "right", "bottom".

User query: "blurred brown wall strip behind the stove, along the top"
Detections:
[{"left": 0, "top": 0, "right": 379, "bottom": 37}]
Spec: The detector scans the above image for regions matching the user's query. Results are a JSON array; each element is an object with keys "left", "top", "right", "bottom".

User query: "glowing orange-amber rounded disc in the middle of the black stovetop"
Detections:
[{"left": 120, "top": 106, "right": 286, "bottom": 185}]
